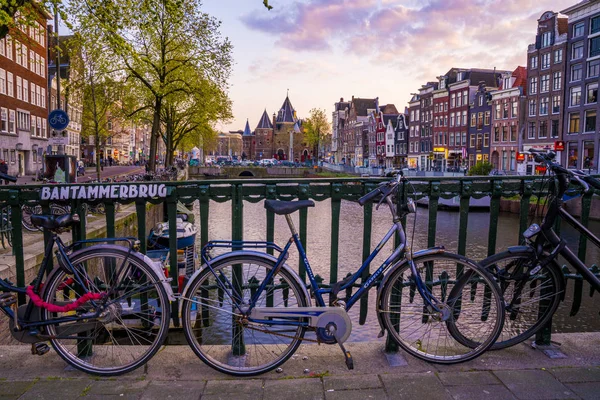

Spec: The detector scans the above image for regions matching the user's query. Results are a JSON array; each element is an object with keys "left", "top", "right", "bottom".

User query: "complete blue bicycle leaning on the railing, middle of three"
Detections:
[{"left": 180, "top": 174, "right": 504, "bottom": 376}]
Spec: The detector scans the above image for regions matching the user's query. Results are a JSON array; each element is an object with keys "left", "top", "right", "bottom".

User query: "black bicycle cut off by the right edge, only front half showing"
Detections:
[{"left": 468, "top": 150, "right": 600, "bottom": 349}]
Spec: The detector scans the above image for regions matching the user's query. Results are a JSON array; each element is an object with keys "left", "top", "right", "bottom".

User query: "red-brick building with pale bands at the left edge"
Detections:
[{"left": 0, "top": 2, "right": 51, "bottom": 175}]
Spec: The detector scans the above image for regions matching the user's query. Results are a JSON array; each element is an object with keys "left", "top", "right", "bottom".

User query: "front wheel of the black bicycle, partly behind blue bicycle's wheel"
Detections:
[{"left": 481, "top": 250, "right": 564, "bottom": 350}]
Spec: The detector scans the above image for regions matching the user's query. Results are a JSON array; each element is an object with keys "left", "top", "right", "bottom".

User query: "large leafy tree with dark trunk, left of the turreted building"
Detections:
[{"left": 71, "top": 0, "right": 232, "bottom": 170}]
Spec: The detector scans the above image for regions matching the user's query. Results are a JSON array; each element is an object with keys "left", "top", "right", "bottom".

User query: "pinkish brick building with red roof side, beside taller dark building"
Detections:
[{"left": 490, "top": 67, "right": 527, "bottom": 173}]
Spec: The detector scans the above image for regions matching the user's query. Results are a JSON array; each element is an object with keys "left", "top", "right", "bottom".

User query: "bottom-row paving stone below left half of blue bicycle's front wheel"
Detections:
[{"left": 381, "top": 373, "right": 451, "bottom": 400}]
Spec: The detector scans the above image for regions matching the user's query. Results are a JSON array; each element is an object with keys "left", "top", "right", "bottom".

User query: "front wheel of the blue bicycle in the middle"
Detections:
[{"left": 378, "top": 253, "right": 504, "bottom": 364}]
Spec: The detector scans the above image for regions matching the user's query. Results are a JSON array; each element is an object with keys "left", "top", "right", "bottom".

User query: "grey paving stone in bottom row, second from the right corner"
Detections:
[{"left": 494, "top": 370, "right": 575, "bottom": 400}]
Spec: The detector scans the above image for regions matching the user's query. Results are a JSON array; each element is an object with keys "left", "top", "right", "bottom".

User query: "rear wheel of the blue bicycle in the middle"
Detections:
[{"left": 182, "top": 255, "right": 309, "bottom": 376}]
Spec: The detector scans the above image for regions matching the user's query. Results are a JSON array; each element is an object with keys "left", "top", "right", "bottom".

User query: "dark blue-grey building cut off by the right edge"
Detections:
[{"left": 564, "top": 0, "right": 600, "bottom": 172}]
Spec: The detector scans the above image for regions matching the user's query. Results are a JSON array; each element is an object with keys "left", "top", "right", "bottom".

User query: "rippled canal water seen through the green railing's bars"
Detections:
[{"left": 195, "top": 200, "right": 600, "bottom": 341}]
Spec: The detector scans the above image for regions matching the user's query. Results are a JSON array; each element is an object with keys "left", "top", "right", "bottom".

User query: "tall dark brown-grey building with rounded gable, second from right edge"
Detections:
[{"left": 523, "top": 11, "right": 568, "bottom": 174}]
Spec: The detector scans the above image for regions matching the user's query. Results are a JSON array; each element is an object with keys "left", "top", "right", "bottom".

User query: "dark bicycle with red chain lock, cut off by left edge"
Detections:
[{"left": 0, "top": 174, "right": 175, "bottom": 376}]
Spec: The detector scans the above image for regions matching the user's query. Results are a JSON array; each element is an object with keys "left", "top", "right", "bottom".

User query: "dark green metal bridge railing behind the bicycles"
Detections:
[{"left": 0, "top": 176, "right": 600, "bottom": 348}]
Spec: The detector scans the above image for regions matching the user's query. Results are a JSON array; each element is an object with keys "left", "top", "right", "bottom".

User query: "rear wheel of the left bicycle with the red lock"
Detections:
[{"left": 42, "top": 245, "right": 170, "bottom": 376}]
